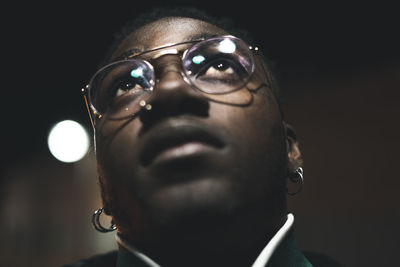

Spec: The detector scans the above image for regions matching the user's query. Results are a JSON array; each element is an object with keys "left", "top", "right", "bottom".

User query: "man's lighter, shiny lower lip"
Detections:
[{"left": 153, "top": 142, "right": 215, "bottom": 164}]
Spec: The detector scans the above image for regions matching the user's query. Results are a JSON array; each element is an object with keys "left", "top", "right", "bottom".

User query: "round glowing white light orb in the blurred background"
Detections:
[{"left": 47, "top": 120, "right": 89, "bottom": 163}]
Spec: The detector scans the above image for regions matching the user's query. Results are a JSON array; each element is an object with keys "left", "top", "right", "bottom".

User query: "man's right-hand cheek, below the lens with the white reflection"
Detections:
[{"left": 210, "top": 90, "right": 286, "bottom": 191}]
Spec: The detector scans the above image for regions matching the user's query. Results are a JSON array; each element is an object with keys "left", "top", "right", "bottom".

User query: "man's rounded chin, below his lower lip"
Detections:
[{"left": 136, "top": 177, "right": 243, "bottom": 232}]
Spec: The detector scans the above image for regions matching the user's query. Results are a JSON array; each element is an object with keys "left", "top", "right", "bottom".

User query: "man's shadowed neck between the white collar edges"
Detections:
[{"left": 120, "top": 209, "right": 286, "bottom": 267}]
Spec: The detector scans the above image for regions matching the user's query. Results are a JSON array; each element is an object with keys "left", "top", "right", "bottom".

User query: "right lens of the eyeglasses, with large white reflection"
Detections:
[{"left": 182, "top": 36, "right": 254, "bottom": 94}]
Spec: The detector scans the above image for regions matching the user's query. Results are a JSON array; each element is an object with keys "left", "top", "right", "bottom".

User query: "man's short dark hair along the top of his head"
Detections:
[{"left": 101, "top": 6, "right": 283, "bottom": 117}]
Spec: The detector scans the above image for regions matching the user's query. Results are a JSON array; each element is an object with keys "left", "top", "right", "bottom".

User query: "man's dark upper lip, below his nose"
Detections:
[{"left": 140, "top": 120, "right": 225, "bottom": 166}]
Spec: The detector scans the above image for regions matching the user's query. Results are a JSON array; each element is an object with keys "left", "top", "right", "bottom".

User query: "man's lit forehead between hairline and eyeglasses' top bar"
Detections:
[{"left": 112, "top": 17, "right": 228, "bottom": 61}]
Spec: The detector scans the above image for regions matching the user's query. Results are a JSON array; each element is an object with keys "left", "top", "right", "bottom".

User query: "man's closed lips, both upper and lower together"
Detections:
[{"left": 140, "top": 120, "right": 225, "bottom": 166}]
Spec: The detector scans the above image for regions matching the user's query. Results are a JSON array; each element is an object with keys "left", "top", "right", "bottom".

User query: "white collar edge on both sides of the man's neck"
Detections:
[{"left": 115, "top": 213, "right": 294, "bottom": 267}]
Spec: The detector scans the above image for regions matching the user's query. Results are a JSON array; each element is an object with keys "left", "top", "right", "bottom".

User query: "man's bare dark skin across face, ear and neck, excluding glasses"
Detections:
[{"left": 96, "top": 18, "right": 301, "bottom": 266}]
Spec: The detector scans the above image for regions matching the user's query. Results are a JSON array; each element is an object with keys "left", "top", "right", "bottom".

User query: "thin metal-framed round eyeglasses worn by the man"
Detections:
[{"left": 82, "top": 35, "right": 258, "bottom": 127}]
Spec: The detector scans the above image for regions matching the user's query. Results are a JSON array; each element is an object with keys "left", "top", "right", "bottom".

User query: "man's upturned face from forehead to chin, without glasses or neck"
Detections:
[{"left": 96, "top": 18, "right": 287, "bottom": 242}]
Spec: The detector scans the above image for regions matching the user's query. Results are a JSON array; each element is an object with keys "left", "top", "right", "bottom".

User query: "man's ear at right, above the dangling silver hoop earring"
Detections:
[{"left": 283, "top": 121, "right": 303, "bottom": 173}]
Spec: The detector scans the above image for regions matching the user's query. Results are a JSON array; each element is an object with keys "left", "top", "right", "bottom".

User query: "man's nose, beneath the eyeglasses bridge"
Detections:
[{"left": 139, "top": 55, "right": 209, "bottom": 126}]
